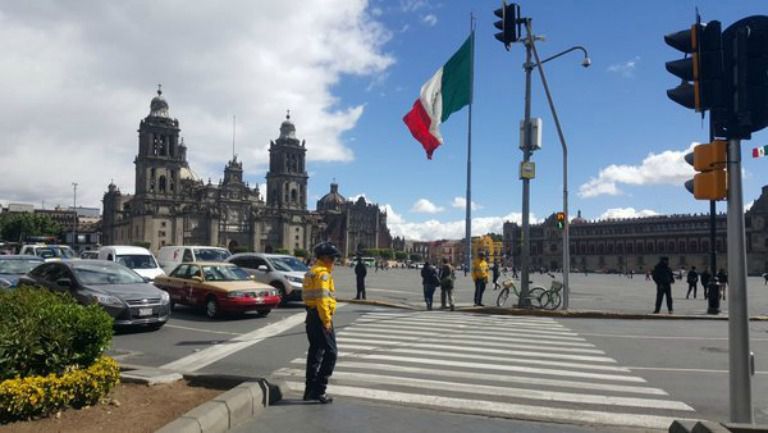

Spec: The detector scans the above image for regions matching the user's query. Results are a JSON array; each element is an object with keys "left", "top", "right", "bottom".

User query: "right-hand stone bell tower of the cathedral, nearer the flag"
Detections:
[{"left": 267, "top": 111, "right": 309, "bottom": 210}]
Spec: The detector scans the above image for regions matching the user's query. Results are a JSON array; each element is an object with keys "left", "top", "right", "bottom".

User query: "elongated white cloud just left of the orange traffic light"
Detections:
[{"left": 579, "top": 143, "right": 698, "bottom": 198}]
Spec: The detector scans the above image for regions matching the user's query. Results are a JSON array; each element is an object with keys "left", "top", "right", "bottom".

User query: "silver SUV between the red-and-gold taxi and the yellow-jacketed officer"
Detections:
[{"left": 227, "top": 253, "right": 309, "bottom": 302}]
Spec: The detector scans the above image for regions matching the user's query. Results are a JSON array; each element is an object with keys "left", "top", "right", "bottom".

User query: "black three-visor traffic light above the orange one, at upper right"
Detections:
[{"left": 664, "top": 21, "right": 723, "bottom": 113}]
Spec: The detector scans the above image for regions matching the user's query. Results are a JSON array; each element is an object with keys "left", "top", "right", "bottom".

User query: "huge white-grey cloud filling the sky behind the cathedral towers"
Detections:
[{"left": 0, "top": 0, "right": 392, "bottom": 206}]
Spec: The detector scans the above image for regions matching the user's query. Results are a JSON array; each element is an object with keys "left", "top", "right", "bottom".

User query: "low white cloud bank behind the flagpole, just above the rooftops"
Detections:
[{"left": 381, "top": 204, "right": 540, "bottom": 241}]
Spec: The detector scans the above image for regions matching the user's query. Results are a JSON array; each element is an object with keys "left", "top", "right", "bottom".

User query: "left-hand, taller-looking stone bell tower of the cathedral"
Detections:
[{"left": 134, "top": 86, "right": 189, "bottom": 199}]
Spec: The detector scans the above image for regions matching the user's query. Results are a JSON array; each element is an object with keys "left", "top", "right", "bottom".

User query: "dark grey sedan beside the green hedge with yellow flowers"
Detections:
[{"left": 20, "top": 260, "right": 171, "bottom": 329}]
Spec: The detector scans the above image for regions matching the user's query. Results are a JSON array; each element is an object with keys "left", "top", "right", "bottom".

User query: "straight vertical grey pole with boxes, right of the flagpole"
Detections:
[{"left": 517, "top": 23, "right": 535, "bottom": 308}]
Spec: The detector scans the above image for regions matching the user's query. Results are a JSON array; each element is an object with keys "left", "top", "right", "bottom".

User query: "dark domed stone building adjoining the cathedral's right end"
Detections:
[{"left": 317, "top": 183, "right": 392, "bottom": 257}]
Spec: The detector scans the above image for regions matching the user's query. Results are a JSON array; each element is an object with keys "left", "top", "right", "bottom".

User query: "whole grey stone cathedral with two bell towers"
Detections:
[{"left": 102, "top": 90, "right": 392, "bottom": 256}]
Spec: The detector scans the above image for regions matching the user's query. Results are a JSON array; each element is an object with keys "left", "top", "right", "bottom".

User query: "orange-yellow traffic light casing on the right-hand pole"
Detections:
[{"left": 685, "top": 140, "right": 728, "bottom": 200}]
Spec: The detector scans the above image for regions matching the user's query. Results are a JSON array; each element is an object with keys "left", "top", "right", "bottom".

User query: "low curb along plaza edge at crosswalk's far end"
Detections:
[{"left": 339, "top": 299, "right": 768, "bottom": 321}]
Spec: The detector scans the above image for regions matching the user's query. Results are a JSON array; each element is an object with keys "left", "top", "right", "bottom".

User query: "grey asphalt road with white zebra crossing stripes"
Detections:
[{"left": 111, "top": 298, "right": 768, "bottom": 432}]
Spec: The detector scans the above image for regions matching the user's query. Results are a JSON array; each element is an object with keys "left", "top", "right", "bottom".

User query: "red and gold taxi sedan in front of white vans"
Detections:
[{"left": 155, "top": 262, "right": 280, "bottom": 319}]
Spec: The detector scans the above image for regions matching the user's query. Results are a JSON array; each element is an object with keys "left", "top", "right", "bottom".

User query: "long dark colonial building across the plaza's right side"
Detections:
[{"left": 503, "top": 186, "right": 768, "bottom": 274}]
